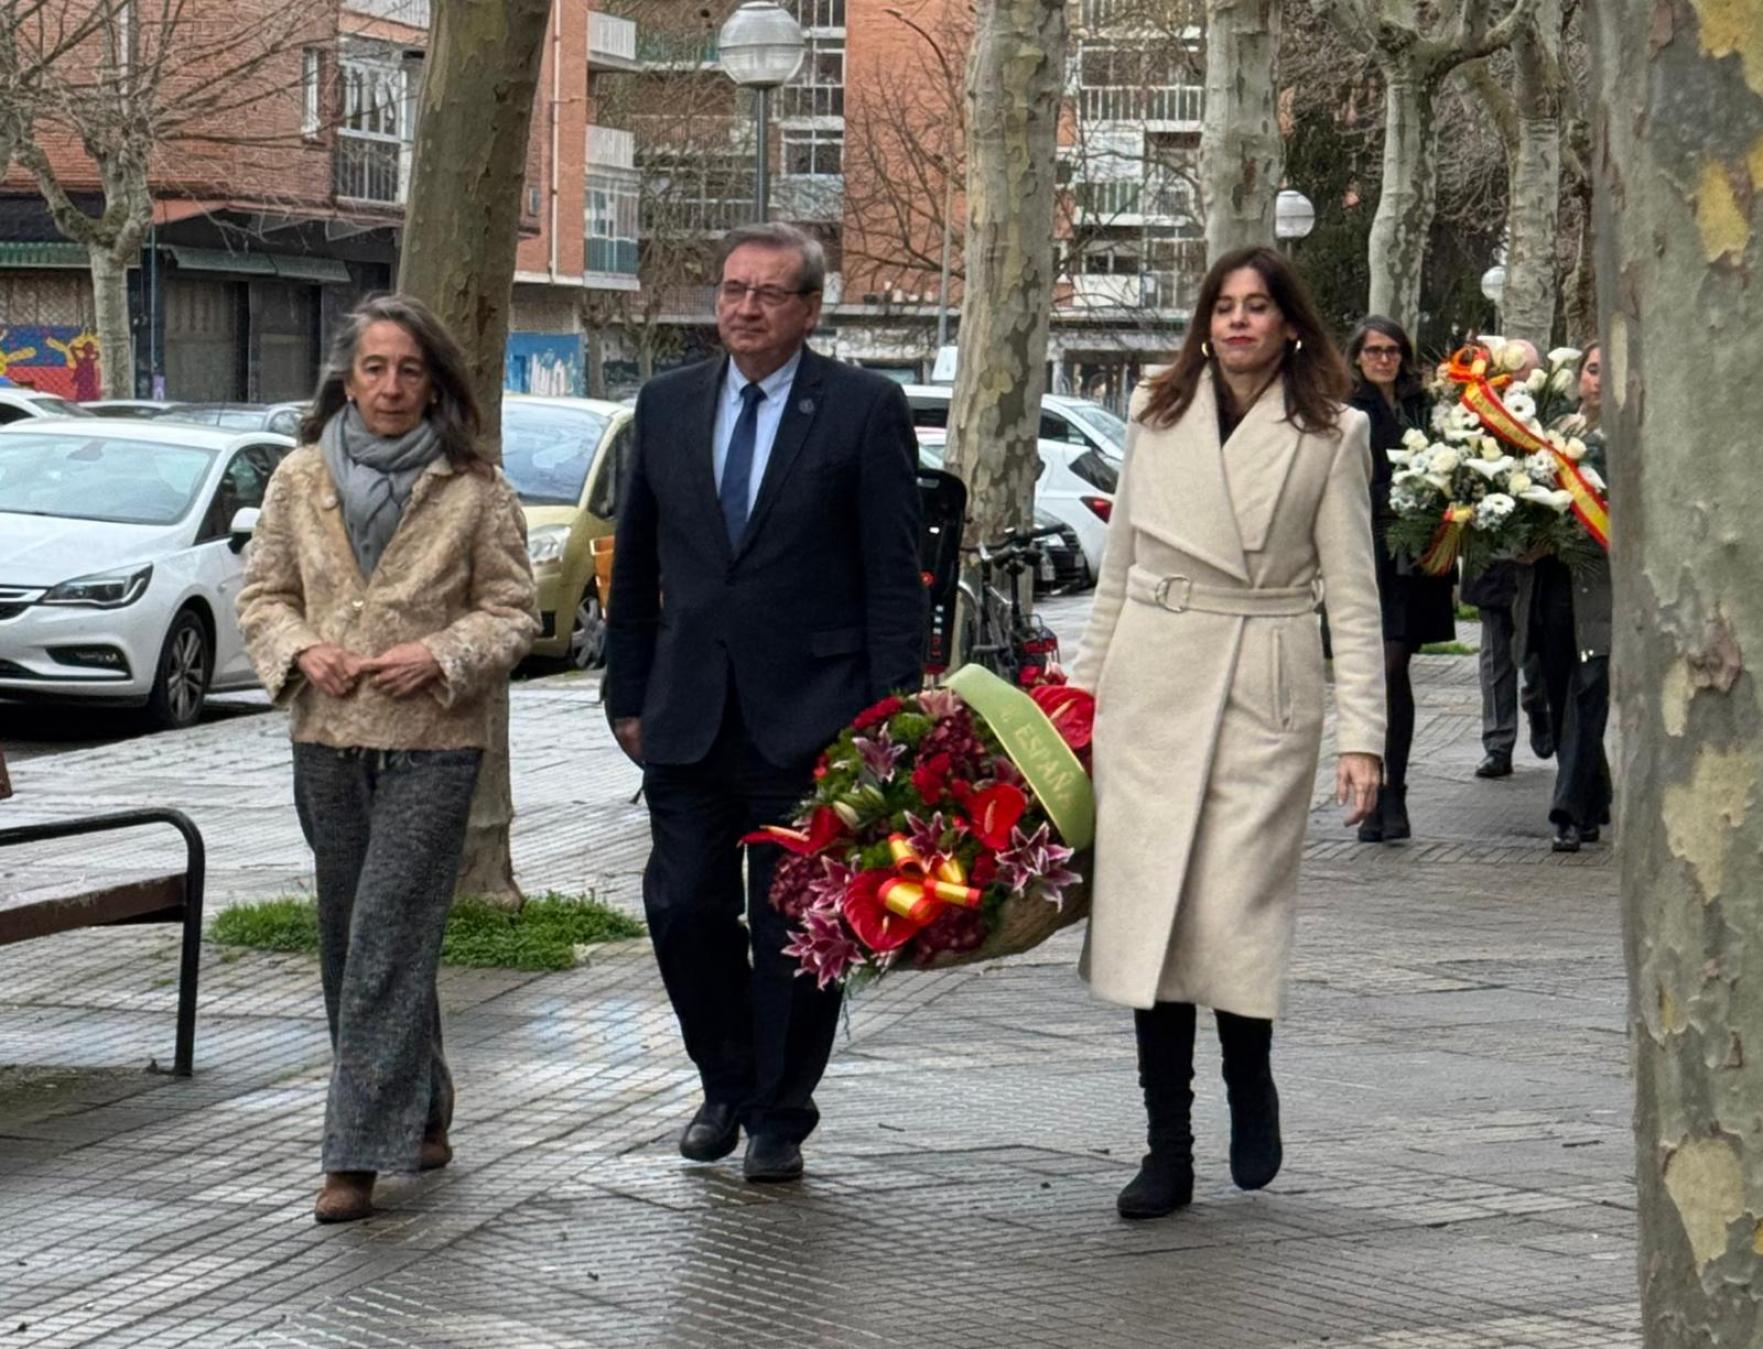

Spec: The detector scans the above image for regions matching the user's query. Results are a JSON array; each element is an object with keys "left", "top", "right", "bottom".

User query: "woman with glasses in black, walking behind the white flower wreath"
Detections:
[{"left": 1347, "top": 314, "right": 1456, "bottom": 843}]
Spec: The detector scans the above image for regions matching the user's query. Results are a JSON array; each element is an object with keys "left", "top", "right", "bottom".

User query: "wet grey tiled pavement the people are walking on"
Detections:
[{"left": 0, "top": 613, "right": 1640, "bottom": 1349}]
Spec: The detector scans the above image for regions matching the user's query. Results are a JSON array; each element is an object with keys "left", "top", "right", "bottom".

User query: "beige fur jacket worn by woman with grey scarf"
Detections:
[{"left": 238, "top": 446, "right": 539, "bottom": 749}]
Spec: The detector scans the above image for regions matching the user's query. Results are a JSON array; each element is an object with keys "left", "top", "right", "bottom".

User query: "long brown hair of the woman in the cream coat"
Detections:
[{"left": 1141, "top": 245, "right": 1352, "bottom": 430}]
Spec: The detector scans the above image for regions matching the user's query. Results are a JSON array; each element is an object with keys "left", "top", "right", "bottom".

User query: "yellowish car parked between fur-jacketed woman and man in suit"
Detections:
[{"left": 502, "top": 393, "right": 635, "bottom": 670}]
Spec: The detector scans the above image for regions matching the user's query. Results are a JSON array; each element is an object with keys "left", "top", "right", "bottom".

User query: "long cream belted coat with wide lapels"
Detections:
[{"left": 1072, "top": 377, "right": 1384, "bottom": 1017}]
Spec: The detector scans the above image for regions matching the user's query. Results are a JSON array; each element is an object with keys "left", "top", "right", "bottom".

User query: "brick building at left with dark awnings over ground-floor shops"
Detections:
[{"left": 0, "top": 0, "right": 636, "bottom": 400}]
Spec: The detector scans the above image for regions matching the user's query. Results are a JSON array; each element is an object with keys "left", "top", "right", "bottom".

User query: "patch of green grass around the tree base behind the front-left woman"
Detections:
[{"left": 208, "top": 892, "right": 643, "bottom": 970}]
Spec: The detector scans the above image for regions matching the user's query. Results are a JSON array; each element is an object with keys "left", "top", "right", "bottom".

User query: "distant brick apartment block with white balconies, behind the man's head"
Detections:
[{"left": 617, "top": 0, "right": 1204, "bottom": 404}]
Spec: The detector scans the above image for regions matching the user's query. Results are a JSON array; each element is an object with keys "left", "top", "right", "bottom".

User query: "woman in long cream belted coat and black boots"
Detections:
[{"left": 1072, "top": 249, "right": 1384, "bottom": 1219}]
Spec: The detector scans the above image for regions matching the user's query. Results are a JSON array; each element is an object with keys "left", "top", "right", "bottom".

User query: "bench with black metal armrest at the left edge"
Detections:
[{"left": 0, "top": 809, "right": 206, "bottom": 1077}]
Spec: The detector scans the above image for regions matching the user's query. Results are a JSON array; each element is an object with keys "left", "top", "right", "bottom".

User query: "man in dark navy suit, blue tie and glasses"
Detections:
[{"left": 606, "top": 224, "right": 924, "bottom": 1181}]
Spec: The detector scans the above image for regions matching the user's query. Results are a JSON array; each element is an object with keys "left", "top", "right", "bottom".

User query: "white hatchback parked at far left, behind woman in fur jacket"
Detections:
[{"left": 0, "top": 418, "right": 294, "bottom": 727}]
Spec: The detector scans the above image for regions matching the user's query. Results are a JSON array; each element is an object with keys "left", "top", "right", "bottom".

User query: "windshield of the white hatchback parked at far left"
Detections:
[{"left": 0, "top": 432, "right": 213, "bottom": 525}]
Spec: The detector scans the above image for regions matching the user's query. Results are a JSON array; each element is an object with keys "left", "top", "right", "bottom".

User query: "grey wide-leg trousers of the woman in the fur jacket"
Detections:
[{"left": 294, "top": 744, "right": 481, "bottom": 1171}]
